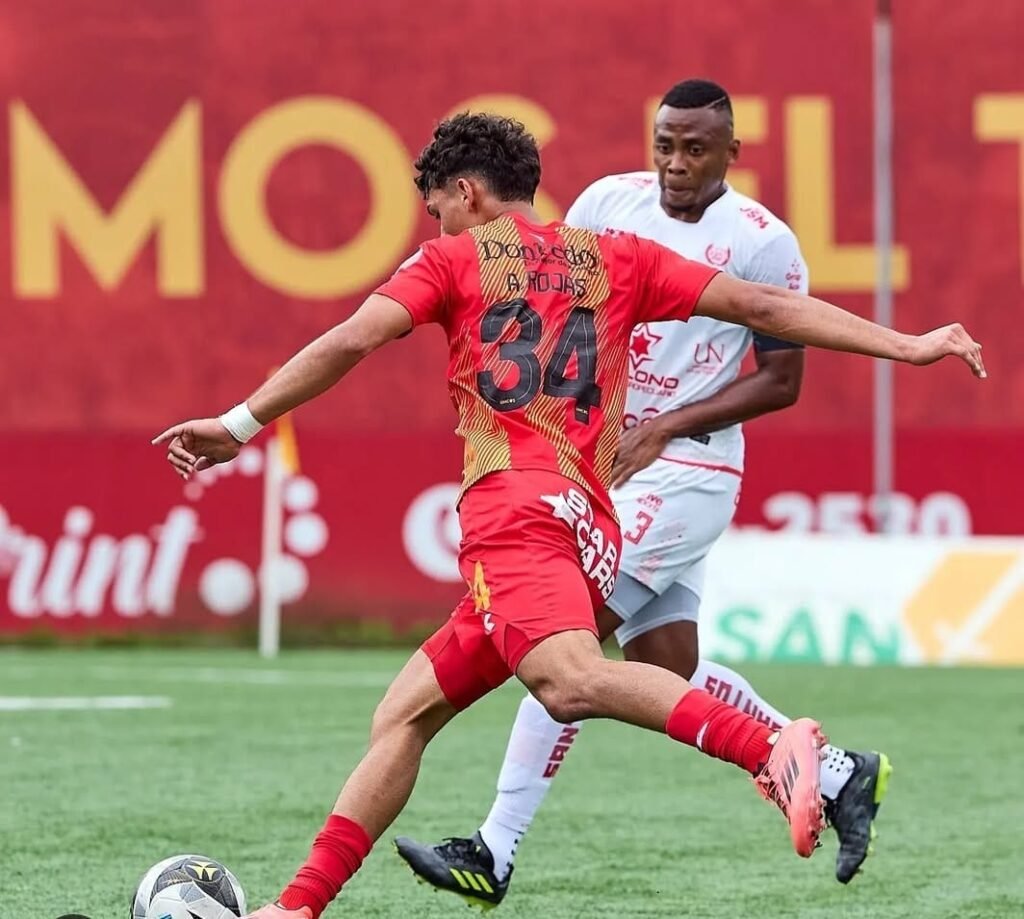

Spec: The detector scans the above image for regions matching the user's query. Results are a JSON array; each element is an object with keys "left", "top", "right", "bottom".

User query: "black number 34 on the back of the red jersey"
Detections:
[{"left": 476, "top": 297, "right": 601, "bottom": 424}]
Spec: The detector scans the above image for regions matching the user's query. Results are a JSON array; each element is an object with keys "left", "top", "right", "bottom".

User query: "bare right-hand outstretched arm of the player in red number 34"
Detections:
[{"left": 694, "top": 273, "right": 985, "bottom": 378}]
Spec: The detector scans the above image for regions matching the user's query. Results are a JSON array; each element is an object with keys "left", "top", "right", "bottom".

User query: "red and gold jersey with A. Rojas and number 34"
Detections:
[{"left": 377, "top": 214, "right": 718, "bottom": 509}]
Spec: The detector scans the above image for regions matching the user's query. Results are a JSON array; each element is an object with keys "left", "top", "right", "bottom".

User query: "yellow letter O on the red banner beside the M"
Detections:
[{"left": 217, "top": 96, "right": 417, "bottom": 299}]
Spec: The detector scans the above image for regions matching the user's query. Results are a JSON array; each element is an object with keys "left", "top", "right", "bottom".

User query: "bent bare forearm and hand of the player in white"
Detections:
[{"left": 611, "top": 348, "right": 804, "bottom": 488}]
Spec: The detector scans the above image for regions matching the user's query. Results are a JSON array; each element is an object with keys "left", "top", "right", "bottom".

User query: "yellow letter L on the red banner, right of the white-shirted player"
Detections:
[{"left": 785, "top": 96, "right": 910, "bottom": 293}]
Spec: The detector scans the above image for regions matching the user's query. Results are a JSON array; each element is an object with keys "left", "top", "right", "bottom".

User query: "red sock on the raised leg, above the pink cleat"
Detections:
[{"left": 665, "top": 690, "right": 773, "bottom": 776}]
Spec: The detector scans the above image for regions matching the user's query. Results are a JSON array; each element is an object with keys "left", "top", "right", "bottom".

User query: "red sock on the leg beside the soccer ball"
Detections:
[{"left": 278, "top": 813, "right": 374, "bottom": 919}]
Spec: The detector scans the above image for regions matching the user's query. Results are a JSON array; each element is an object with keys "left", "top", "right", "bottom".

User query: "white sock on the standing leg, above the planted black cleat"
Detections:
[{"left": 480, "top": 695, "right": 581, "bottom": 878}]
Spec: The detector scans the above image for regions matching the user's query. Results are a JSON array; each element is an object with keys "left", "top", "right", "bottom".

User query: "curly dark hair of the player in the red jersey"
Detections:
[{"left": 414, "top": 112, "right": 541, "bottom": 203}]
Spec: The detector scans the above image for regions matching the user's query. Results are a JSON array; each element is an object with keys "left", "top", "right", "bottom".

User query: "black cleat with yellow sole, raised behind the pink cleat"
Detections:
[{"left": 825, "top": 751, "right": 893, "bottom": 884}]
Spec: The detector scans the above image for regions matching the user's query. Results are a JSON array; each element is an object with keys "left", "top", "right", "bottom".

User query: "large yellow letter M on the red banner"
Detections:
[{"left": 9, "top": 100, "right": 204, "bottom": 297}]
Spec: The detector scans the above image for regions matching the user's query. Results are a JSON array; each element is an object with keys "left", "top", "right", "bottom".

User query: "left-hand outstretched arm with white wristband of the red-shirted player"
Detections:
[{"left": 153, "top": 294, "right": 413, "bottom": 478}]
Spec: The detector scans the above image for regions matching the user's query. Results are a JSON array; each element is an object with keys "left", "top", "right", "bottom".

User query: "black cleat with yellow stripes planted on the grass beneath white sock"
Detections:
[{"left": 394, "top": 833, "right": 512, "bottom": 910}]
